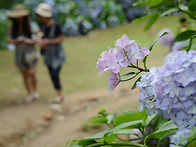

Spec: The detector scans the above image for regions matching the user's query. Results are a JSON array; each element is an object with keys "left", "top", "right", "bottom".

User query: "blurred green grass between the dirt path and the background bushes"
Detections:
[{"left": 0, "top": 16, "right": 179, "bottom": 107}]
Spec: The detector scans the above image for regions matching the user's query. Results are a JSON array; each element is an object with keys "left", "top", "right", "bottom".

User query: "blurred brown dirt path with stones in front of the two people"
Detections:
[{"left": 0, "top": 85, "right": 138, "bottom": 147}]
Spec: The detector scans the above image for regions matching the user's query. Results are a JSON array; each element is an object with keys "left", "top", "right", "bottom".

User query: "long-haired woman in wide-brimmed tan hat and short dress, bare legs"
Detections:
[{"left": 7, "top": 4, "right": 39, "bottom": 102}]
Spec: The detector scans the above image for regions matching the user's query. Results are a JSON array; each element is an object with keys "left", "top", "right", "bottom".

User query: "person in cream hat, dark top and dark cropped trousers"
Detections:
[{"left": 35, "top": 3, "right": 65, "bottom": 103}]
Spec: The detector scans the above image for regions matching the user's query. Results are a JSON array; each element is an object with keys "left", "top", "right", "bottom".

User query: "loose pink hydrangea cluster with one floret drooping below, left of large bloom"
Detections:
[{"left": 97, "top": 35, "right": 150, "bottom": 92}]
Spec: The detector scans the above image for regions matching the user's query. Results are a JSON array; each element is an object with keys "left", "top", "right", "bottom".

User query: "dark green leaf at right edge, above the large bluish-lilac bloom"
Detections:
[{"left": 174, "top": 30, "right": 196, "bottom": 42}]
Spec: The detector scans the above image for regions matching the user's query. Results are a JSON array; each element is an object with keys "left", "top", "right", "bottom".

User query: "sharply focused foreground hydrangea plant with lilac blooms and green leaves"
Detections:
[{"left": 70, "top": 0, "right": 196, "bottom": 147}]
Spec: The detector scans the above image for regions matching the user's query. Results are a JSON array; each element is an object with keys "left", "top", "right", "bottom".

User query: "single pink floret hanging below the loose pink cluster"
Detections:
[{"left": 108, "top": 72, "right": 120, "bottom": 93}]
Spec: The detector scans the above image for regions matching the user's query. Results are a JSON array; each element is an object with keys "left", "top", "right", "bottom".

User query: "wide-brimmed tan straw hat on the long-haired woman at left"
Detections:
[{"left": 7, "top": 4, "right": 30, "bottom": 18}]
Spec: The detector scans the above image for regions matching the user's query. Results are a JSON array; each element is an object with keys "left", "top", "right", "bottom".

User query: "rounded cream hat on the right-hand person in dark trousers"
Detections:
[{"left": 35, "top": 3, "right": 52, "bottom": 18}]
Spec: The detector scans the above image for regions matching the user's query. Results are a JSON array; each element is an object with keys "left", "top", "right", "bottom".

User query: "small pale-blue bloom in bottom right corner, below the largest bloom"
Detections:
[{"left": 169, "top": 129, "right": 191, "bottom": 147}]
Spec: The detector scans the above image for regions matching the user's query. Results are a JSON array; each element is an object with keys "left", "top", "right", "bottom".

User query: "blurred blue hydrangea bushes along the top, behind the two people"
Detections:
[{"left": 0, "top": 0, "right": 145, "bottom": 49}]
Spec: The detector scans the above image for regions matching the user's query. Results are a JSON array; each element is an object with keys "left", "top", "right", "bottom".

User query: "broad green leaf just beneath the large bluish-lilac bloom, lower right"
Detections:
[{"left": 148, "top": 121, "right": 177, "bottom": 139}]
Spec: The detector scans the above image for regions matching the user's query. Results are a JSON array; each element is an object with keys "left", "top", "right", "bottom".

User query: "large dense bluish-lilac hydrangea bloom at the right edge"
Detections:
[{"left": 138, "top": 50, "right": 196, "bottom": 130}]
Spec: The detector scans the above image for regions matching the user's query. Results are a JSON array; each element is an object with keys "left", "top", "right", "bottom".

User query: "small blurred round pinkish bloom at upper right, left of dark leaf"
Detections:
[{"left": 158, "top": 28, "right": 174, "bottom": 46}]
